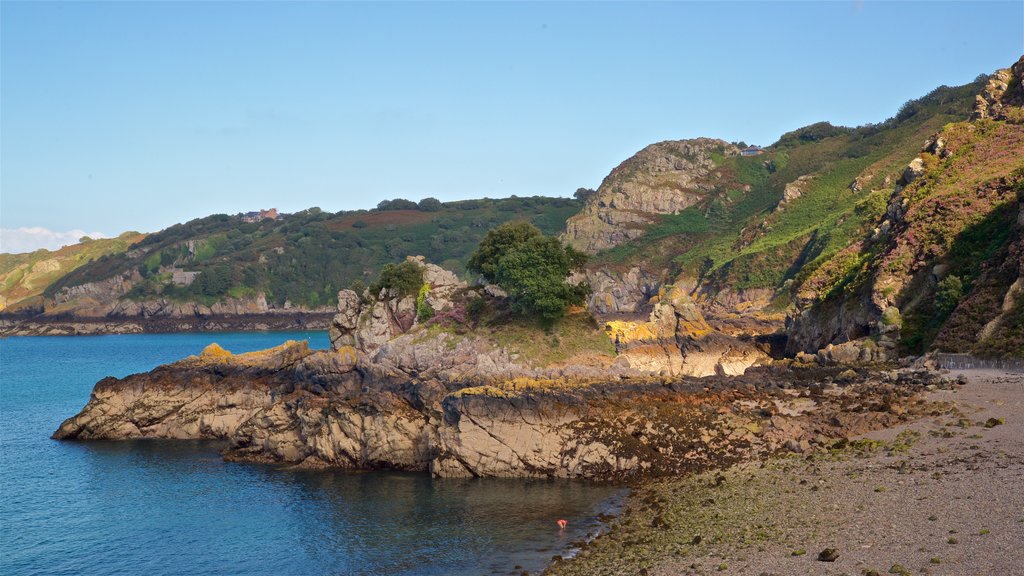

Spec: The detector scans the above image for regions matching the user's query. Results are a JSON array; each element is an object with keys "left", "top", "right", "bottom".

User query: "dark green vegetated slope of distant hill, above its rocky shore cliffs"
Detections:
[{"left": 39, "top": 198, "right": 580, "bottom": 306}]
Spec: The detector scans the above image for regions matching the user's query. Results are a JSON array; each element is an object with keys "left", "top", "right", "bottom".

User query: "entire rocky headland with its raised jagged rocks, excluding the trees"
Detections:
[{"left": 54, "top": 258, "right": 946, "bottom": 481}]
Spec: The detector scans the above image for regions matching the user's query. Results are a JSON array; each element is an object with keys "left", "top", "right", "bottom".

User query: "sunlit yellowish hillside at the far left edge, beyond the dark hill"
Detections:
[{"left": 0, "top": 232, "right": 145, "bottom": 312}]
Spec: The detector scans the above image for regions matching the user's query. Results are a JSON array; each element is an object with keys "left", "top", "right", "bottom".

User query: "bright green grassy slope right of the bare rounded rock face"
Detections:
[{"left": 594, "top": 82, "right": 980, "bottom": 305}]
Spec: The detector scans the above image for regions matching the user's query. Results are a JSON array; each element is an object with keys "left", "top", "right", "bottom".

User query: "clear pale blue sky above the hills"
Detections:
[{"left": 0, "top": 0, "right": 1024, "bottom": 252}]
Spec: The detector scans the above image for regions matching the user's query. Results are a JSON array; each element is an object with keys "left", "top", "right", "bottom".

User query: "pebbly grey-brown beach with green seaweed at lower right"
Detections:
[{"left": 545, "top": 370, "right": 1024, "bottom": 576}]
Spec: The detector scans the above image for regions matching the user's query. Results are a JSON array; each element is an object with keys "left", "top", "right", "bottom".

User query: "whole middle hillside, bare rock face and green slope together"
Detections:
[{"left": 565, "top": 71, "right": 987, "bottom": 332}]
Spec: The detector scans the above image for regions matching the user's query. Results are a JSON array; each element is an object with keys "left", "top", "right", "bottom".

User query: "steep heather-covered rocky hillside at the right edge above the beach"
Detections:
[{"left": 790, "top": 57, "right": 1024, "bottom": 356}]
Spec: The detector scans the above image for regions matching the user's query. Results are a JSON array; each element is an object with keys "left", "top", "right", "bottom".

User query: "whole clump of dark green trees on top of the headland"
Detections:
[{"left": 469, "top": 222, "right": 590, "bottom": 325}]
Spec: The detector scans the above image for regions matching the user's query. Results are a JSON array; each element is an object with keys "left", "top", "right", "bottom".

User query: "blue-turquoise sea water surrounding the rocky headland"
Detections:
[{"left": 0, "top": 332, "right": 618, "bottom": 575}]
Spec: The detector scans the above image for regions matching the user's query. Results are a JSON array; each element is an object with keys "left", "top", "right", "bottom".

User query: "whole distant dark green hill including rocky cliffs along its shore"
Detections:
[{"left": 16, "top": 193, "right": 580, "bottom": 318}]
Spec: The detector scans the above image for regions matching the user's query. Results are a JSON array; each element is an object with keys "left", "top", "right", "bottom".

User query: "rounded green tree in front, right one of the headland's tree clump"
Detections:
[{"left": 495, "top": 236, "right": 590, "bottom": 325}]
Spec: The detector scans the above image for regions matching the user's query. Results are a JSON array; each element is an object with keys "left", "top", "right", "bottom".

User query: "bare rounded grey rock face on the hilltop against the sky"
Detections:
[{"left": 564, "top": 138, "right": 739, "bottom": 254}]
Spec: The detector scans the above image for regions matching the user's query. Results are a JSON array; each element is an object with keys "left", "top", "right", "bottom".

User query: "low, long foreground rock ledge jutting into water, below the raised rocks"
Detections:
[{"left": 54, "top": 336, "right": 937, "bottom": 480}]
